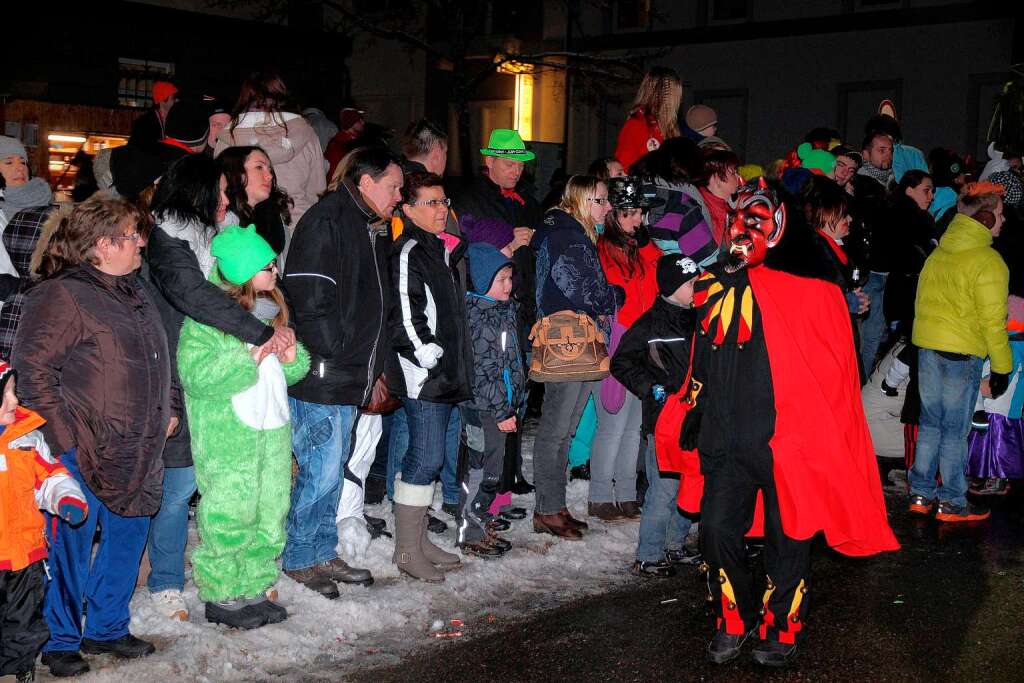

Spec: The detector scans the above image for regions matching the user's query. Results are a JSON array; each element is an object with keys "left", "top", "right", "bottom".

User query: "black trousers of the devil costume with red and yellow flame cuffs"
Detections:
[{"left": 700, "top": 449, "right": 811, "bottom": 644}]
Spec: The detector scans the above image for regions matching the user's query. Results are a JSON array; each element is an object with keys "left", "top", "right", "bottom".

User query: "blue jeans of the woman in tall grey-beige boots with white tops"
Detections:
[{"left": 401, "top": 398, "right": 461, "bottom": 489}]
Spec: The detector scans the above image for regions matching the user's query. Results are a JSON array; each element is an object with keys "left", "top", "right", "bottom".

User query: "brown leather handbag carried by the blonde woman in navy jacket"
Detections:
[{"left": 529, "top": 310, "right": 609, "bottom": 382}]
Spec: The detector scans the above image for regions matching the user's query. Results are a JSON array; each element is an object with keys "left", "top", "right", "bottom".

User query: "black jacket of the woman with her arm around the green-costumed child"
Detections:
[{"left": 141, "top": 216, "right": 273, "bottom": 467}]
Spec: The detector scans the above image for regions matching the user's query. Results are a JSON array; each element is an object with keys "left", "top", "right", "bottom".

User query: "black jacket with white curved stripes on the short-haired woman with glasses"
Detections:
[{"left": 385, "top": 221, "right": 473, "bottom": 403}]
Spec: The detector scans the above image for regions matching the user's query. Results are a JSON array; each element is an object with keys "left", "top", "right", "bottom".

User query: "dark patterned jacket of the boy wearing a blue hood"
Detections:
[{"left": 466, "top": 292, "right": 526, "bottom": 422}]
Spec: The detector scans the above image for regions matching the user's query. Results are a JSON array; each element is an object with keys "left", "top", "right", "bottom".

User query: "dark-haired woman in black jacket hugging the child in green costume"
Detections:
[{"left": 140, "top": 155, "right": 295, "bottom": 621}]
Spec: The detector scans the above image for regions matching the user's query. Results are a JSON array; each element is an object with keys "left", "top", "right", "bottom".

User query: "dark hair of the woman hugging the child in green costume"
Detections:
[{"left": 151, "top": 155, "right": 221, "bottom": 233}]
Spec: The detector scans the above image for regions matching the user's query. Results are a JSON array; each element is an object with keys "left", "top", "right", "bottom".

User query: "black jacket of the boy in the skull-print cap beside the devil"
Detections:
[{"left": 611, "top": 297, "right": 696, "bottom": 434}]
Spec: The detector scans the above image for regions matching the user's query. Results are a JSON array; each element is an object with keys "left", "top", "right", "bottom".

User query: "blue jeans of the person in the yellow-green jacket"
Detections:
[{"left": 907, "top": 348, "right": 983, "bottom": 506}]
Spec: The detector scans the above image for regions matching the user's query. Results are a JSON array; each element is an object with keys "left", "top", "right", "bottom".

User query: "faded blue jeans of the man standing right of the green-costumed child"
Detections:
[{"left": 282, "top": 398, "right": 359, "bottom": 571}]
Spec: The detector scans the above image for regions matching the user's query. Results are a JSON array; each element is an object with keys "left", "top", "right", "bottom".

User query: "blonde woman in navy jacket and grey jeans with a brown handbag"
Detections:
[{"left": 531, "top": 175, "right": 623, "bottom": 541}]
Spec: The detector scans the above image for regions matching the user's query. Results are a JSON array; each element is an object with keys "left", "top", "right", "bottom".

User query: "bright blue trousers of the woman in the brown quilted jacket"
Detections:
[{"left": 42, "top": 449, "right": 150, "bottom": 652}]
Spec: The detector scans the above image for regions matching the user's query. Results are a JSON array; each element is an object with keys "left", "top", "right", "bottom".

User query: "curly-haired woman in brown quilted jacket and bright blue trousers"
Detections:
[{"left": 12, "top": 193, "right": 173, "bottom": 676}]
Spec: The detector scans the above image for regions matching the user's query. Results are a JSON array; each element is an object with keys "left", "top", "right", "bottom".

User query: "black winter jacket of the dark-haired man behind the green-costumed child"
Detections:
[{"left": 285, "top": 181, "right": 391, "bottom": 405}]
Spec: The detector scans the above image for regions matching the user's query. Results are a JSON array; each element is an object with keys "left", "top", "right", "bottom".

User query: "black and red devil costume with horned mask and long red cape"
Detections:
[{"left": 679, "top": 179, "right": 899, "bottom": 645}]
